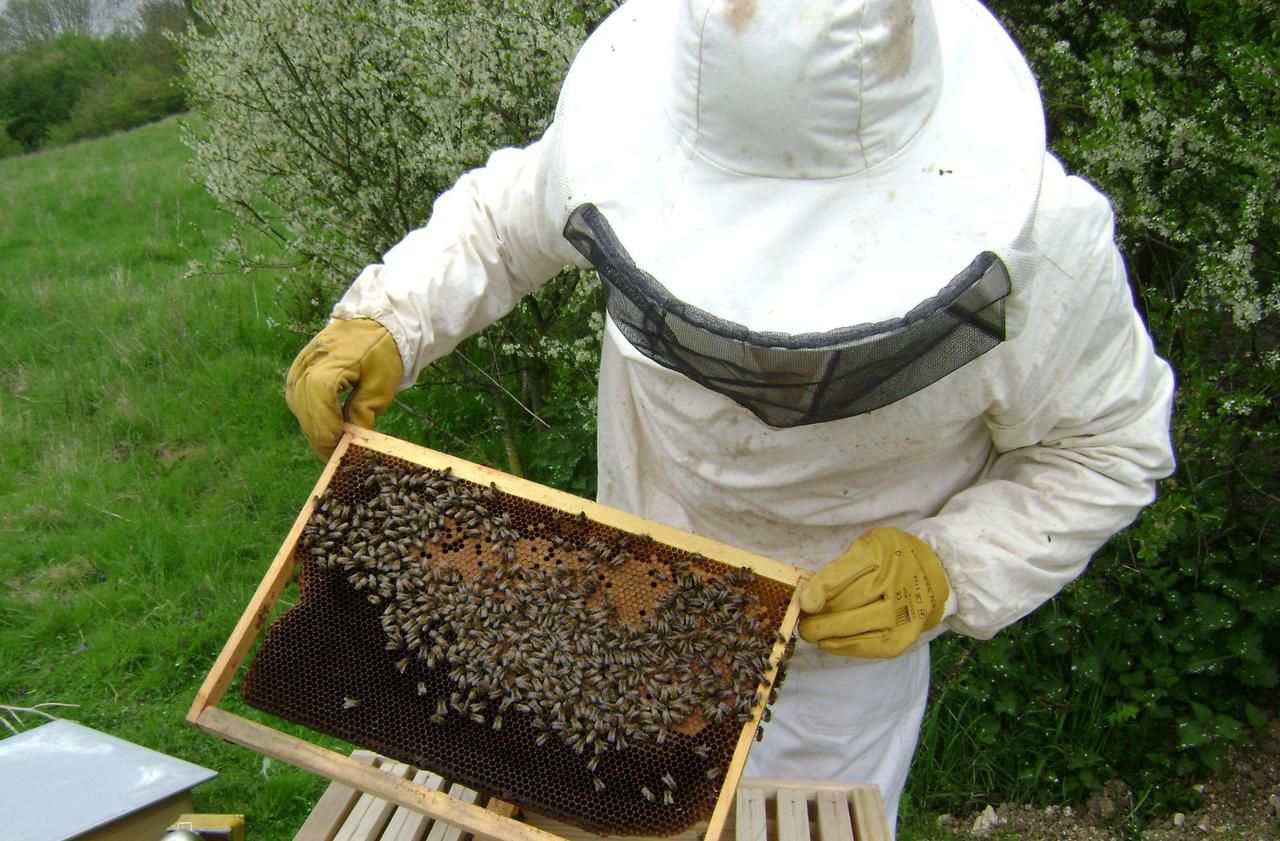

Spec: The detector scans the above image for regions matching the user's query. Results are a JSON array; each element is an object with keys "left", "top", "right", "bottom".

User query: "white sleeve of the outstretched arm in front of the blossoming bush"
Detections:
[{"left": 333, "top": 132, "right": 582, "bottom": 389}]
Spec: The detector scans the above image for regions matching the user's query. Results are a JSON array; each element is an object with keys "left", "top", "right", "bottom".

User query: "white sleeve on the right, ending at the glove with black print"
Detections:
[{"left": 911, "top": 159, "right": 1174, "bottom": 639}]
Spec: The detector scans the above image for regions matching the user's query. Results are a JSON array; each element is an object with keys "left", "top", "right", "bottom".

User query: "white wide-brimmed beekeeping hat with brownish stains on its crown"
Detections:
[{"left": 556, "top": 0, "right": 1044, "bottom": 333}]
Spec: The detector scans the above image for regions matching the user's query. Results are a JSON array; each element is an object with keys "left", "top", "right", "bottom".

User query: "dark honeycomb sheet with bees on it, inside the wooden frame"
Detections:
[{"left": 241, "top": 445, "right": 792, "bottom": 835}]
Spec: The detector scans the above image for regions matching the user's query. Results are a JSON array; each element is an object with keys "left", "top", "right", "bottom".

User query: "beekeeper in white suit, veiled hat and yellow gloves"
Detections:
[{"left": 287, "top": 0, "right": 1172, "bottom": 829}]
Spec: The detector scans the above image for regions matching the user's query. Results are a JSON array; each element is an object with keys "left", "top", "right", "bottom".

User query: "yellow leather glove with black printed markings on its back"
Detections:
[{"left": 800, "top": 527, "right": 951, "bottom": 658}]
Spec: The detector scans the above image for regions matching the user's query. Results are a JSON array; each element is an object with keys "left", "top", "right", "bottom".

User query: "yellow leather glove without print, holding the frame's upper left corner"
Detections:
[{"left": 284, "top": 319, "right": 404, "bottom": 458}]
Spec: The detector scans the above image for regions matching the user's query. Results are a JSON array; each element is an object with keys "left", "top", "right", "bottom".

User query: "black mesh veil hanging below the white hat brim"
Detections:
[{"left": 564, "top": 205, "right": 1010, "bottom": 428}]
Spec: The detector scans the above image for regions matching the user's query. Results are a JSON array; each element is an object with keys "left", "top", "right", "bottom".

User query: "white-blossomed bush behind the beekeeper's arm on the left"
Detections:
[{"left": 182, "top": 0, "right": 612, "bottom": 481}]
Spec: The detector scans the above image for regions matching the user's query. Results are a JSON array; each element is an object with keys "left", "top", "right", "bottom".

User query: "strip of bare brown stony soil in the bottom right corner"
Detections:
[{"left": 921, "top": 719, "right": 1280, "bottom": 841}]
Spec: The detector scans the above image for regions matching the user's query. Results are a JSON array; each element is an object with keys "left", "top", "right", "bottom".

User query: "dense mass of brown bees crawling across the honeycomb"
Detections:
[{"left": 300, "top": 455, "right": 777, "bottom": 804}]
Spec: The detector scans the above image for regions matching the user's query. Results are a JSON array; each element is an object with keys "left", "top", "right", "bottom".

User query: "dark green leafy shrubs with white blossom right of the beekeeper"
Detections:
[{"left": 913, "top": 0, "right": 1280, "bottom": 812}]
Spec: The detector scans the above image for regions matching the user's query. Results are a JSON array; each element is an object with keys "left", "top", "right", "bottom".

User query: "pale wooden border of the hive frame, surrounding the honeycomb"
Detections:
[{"left": 187, "top": 425, "right": 808, "bottom": 841}]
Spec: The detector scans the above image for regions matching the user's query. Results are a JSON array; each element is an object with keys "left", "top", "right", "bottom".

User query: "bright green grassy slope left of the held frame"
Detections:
[{"left": 0, "top": 120, "right": 335, "bottom": 841}]
